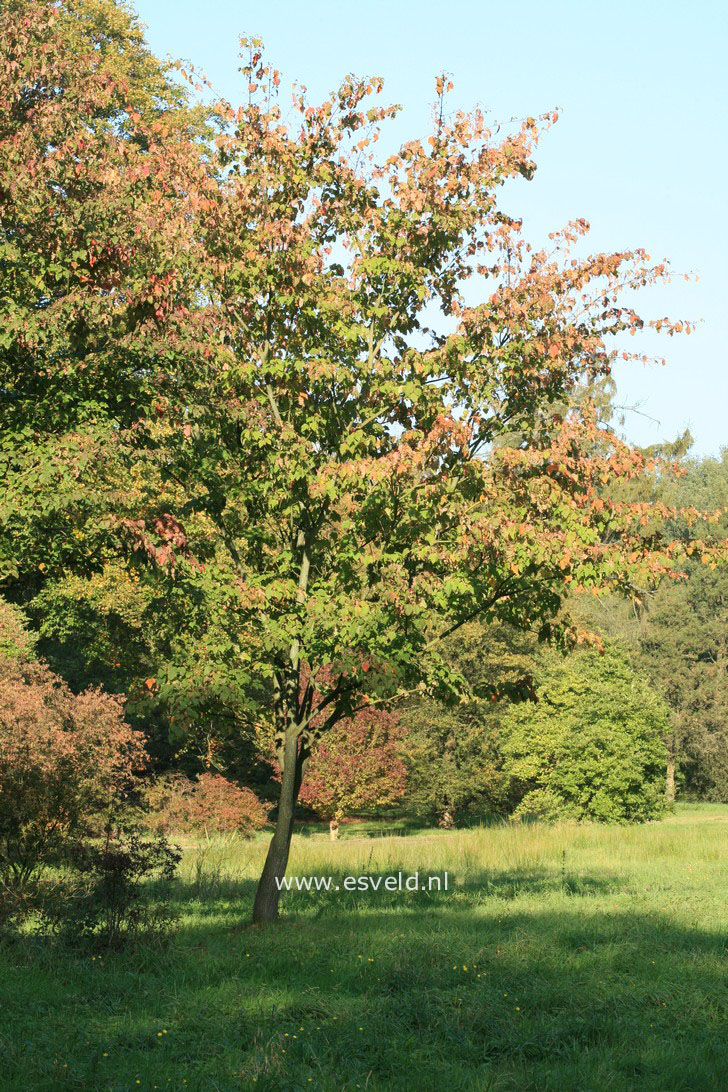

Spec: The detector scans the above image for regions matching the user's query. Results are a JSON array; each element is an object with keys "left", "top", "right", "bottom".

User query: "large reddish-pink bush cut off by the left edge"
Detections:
[{"left": 0, "top": 604, "right": 146, "bottom": 891}]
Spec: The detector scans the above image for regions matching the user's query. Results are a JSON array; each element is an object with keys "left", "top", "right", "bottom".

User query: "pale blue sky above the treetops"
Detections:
[{"left": 134, "top": 0, "right": 728, "bottom": 454}]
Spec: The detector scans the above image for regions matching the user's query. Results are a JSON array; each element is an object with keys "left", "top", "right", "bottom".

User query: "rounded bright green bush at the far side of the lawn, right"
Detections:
[{"left": 503, "top": 649, "right": 669, "bottom": 822}]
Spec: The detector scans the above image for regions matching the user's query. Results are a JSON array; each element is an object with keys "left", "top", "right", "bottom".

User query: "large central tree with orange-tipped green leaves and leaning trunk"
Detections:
[{"left": 1, "top": 17, "right": 715, "bottom": 922}]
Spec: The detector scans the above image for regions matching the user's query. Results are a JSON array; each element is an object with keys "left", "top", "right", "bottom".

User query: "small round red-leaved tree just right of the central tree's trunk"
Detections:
[{"left": 299, "top": 709, "right": 407, "bottom": 839}]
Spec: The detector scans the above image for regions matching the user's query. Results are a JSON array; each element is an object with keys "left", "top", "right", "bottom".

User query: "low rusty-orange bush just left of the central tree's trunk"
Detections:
[{"left": 147, "top": 773, "right": 268, "bottom": 838}]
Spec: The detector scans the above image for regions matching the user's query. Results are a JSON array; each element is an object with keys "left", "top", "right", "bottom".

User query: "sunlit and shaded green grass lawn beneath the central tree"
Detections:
[{"left": 0, "top": 805, "right": 728, "bottom": 1092}]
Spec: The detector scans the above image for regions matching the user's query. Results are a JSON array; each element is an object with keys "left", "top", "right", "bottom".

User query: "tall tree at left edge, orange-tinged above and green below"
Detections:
[{"left": 0, "top": 0, "right": 236, "bottom": 768}]
